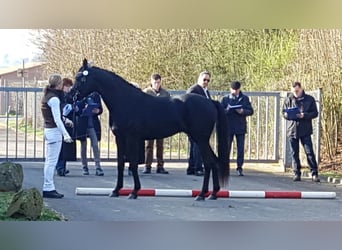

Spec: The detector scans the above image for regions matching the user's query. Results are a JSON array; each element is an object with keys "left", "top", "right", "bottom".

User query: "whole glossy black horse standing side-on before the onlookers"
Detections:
[{"left": 74, "top": 59, "right": 229, "bottom": 200}]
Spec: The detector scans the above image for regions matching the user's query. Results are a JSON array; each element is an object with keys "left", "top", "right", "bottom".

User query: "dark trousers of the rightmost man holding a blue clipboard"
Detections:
[{"left": 290, "top": 135, "right": 318, "bottom": 175}]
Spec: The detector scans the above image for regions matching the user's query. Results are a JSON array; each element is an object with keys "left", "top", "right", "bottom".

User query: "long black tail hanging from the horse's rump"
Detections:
[{"left": 213, "top": 101, "right": 230, "bottom": 187}]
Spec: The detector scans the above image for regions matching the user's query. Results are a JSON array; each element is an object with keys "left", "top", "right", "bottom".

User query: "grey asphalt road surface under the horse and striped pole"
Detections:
[{"left": 21, "top": 162, "right": 342, "bottom": 221}]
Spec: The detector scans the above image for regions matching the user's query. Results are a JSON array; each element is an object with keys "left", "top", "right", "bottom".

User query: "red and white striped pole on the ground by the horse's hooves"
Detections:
[{"left": 75, "top": 187, "right": 336, "bottom": 199}]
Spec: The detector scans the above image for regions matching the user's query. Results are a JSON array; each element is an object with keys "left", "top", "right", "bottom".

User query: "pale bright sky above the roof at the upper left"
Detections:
[{"left": 0, "top": 29, "right": 39, "bottom": 68}]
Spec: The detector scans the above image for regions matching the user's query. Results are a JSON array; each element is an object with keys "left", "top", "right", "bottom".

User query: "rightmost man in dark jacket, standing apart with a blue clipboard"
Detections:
[{"left": 283, "top": 82, "right": 320, "bottom": 182}]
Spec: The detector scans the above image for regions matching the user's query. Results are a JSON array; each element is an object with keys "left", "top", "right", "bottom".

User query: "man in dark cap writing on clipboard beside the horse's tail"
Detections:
[{"left": 221, "top": 81, "right": 254, "bottom": 176}]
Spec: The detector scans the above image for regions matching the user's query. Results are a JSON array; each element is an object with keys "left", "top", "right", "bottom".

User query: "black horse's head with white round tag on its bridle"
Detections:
[{"left": 73, "top": 59, "right": 96, "bottom": 99}]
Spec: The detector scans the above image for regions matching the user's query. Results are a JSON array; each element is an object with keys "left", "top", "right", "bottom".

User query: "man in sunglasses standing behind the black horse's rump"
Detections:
[{"left": 186, "top": 71, "right": 211, "bottom": 176}]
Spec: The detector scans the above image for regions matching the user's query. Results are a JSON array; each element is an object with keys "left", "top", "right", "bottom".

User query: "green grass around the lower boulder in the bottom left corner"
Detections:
[{"left": 0, "top": 192, "right": 64, "bottom": 221}]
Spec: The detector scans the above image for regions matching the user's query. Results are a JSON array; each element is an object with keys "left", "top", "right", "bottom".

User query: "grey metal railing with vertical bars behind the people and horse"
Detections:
[{"left": 0, "top": 87, "right": 320, "bottom": 170}]
